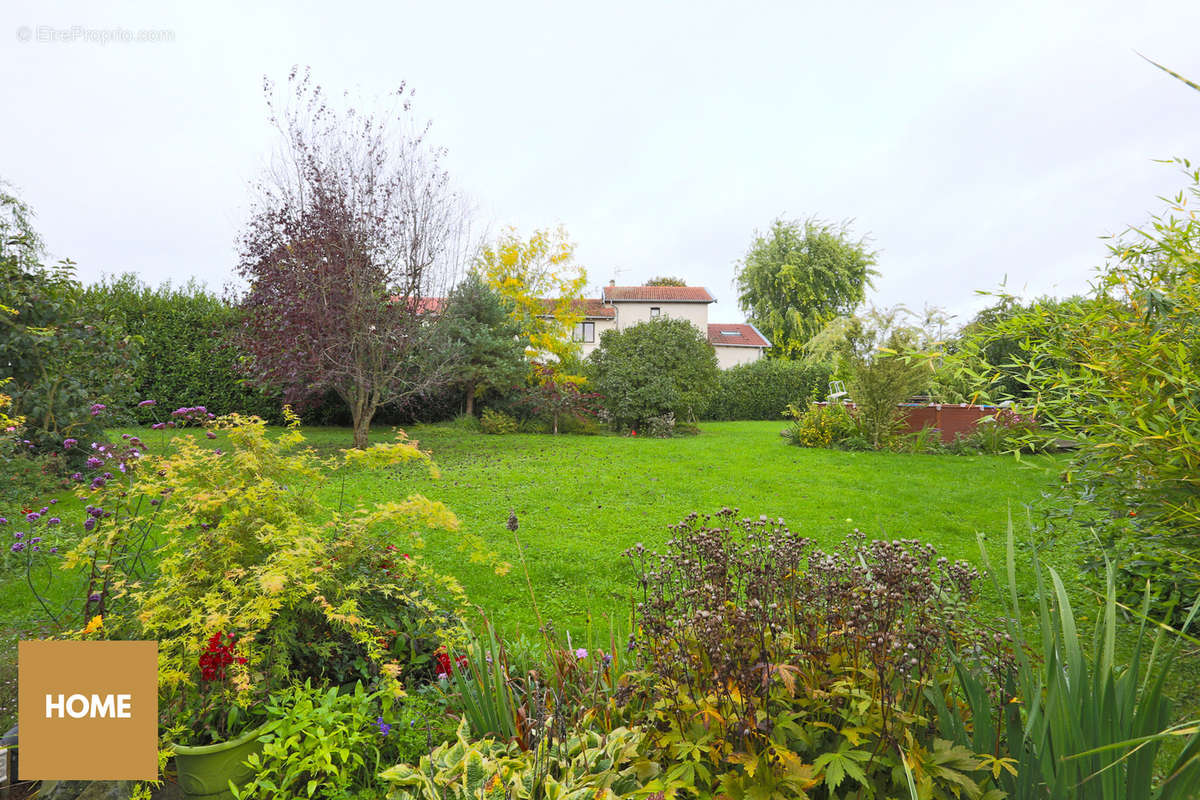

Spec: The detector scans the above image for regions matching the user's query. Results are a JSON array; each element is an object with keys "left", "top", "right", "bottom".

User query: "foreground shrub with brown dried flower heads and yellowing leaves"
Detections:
[{"left": 626, "top": 509, "right": 1000, "bottom": 798}]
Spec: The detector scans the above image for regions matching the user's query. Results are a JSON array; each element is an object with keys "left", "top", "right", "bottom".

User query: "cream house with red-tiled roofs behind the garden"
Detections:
[{"left": 561, "top": 283, "right": 770, "bottom": 369}]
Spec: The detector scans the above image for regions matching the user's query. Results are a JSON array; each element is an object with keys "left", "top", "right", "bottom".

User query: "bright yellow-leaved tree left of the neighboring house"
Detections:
[{"left": 475, "top": 227, "right": 588, "bottom": 363}]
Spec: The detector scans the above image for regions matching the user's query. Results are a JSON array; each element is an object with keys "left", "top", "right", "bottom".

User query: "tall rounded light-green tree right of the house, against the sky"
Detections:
[{"left": 737, "top": 217, "right": 878, "bottom": 357}]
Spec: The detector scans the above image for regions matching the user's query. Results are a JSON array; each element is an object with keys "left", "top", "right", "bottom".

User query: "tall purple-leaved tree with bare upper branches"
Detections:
[{"left": 240, "top": 70, "right": 466, "bottom": 447}]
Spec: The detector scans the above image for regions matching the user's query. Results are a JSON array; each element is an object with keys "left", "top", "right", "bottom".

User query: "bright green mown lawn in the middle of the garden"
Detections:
[{"left": 0, "top": 422, "right": 1070, "bottom": 727}]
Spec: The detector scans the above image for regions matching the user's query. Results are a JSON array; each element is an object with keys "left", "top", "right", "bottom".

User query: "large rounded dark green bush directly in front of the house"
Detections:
[{"left": 588, "top": 317, "right": 718, "bottom": 431}]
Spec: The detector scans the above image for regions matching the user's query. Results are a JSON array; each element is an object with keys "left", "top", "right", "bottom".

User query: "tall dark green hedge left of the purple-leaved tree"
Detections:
[{"left": 84, "top": 275, "right": 282, "bottom": 423}]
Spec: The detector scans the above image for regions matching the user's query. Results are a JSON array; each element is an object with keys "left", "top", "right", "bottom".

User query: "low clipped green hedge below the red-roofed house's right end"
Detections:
[{"left": 704, "top": 359, "right": 830, "bottom": 420}]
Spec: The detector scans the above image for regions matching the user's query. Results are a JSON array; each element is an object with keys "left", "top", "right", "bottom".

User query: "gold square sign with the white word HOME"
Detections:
[{"left": 17, "top": 640, "right": 158, "bottom": 781}]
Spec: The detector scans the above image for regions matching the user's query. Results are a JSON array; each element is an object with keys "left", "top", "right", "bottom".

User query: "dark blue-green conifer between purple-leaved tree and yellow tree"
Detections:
[{"left": 444, "top": 272, "right": 528, "bottom": 414}]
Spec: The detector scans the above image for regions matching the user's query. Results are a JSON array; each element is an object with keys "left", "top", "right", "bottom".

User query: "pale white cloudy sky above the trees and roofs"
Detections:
[{"left": 0, "top": 0, "right": 1200, "bottom": 321}]
